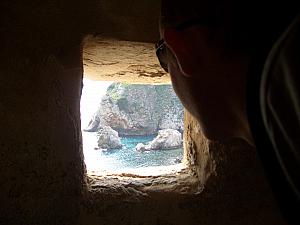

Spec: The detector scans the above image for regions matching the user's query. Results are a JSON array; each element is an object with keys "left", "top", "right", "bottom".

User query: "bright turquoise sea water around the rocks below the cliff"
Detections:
[{"left": 82, "top": 132, "right": 183, "bottom": 171}]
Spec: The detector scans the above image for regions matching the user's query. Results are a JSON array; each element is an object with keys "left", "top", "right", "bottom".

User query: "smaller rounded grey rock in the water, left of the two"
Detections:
[{"left": 98, "top": 126, "right": 122, "bottom": 149}]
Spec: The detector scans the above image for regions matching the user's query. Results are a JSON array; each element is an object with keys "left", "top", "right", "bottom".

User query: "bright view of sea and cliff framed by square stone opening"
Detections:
[{"left": 81, "top": 78, "right": 184, "bottom": 175}]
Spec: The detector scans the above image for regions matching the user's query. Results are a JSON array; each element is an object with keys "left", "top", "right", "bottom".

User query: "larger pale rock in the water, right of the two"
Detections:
[{"left": 135, "top": 129, "right": 182, "bottom": 151}]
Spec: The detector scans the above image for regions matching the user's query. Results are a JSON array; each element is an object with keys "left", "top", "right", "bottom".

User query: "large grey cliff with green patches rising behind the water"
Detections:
[{"left": 85, "top": 83, "right": 183, "bottom": 136}]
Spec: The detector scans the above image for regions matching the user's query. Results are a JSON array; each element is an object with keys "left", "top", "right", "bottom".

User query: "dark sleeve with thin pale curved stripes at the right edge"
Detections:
[{"left": 260, "top": 12, "right": 300, "bottom": 204}]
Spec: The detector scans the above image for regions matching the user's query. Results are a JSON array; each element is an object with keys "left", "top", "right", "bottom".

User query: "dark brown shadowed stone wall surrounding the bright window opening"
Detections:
[{"left": 0, "top": 0, "right": 284, "bottom": 225}]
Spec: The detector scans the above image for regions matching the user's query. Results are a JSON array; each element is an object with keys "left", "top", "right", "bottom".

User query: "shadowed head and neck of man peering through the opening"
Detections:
[{"left": 158, "top": 0, "right": 296, "bottom": 143}]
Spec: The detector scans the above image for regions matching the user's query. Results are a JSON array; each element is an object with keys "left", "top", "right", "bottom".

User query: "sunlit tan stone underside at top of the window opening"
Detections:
[{"left": 83, "top": 37, "right": 170, "bottom": 84}]
